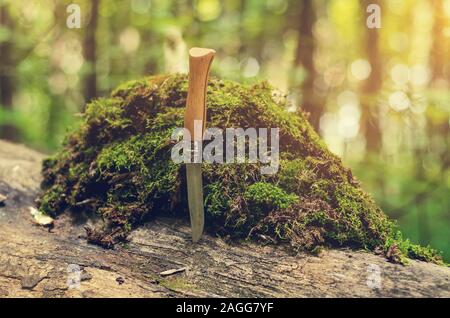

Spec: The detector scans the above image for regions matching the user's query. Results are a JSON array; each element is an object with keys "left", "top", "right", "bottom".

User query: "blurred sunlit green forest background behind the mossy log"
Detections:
[{"left": 0, "top": 0, "right": 450, "bottom": 261}]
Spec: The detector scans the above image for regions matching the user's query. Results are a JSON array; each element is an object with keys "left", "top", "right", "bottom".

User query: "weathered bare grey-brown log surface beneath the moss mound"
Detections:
[{"left": 0, "top": 141, "right": 450, "bottom": 297}]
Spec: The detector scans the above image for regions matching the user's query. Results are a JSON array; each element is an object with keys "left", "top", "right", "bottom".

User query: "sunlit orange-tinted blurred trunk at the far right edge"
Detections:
[{"left": 430, "top": 0, "right": 450, "bottom": 82}]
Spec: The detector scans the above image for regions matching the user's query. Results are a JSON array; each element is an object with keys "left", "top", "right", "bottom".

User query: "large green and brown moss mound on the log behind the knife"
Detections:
[{"left": 39, "top": 75, "right": 440, "bottom": 263}]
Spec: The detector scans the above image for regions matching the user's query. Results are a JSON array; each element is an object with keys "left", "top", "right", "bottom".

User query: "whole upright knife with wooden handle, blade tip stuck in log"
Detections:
[{"left": 184, "top": 48, "right": 216, "bottom": 243}]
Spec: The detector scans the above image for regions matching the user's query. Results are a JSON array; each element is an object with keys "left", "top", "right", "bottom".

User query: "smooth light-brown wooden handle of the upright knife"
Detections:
[{"left": 184, "top": 48, "right": 216, "bottom": 141}]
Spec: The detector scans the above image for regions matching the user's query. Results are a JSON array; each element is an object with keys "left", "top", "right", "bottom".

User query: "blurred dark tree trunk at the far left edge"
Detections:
[{"left": 0, "top": 3, "right": 18, "bottom": 140}]
